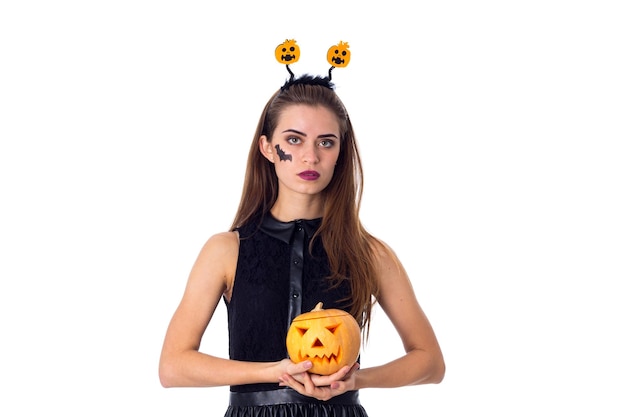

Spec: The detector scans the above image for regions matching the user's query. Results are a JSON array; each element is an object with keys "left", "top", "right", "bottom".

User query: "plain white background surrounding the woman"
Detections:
[{"left": 0, "top": 0, "right": 626, "bottom": 417}]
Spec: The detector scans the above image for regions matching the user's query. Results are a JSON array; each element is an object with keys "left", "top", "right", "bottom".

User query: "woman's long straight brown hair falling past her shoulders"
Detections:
[{"left": 231, "top": 77, "right": 379, "bottom": 334}]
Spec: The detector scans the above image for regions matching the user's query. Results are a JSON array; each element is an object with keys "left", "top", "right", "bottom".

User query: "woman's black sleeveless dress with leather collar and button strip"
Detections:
[{"left": 225, "top": 213, "right": 367, "bottom": 417}]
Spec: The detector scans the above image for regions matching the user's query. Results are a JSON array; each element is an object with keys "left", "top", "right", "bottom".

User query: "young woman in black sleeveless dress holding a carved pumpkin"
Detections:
[{"left": 159, "top": 75, "right": 445, "bottom": 417}]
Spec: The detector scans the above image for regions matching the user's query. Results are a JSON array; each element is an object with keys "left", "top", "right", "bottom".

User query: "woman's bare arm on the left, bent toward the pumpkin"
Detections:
[{"left": 159, "top": 232, "right": 306, "bottom": 387}]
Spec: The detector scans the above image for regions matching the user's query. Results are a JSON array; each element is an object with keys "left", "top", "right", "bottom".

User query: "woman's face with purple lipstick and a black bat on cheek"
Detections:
[{"left": 260, "top": 104, "right": 340, "bottom": 195}]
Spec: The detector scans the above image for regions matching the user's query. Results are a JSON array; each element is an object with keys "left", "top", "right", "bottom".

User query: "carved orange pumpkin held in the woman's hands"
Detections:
[{"left": 287, "top": 303, "right": 361, "bottom": 375}]
